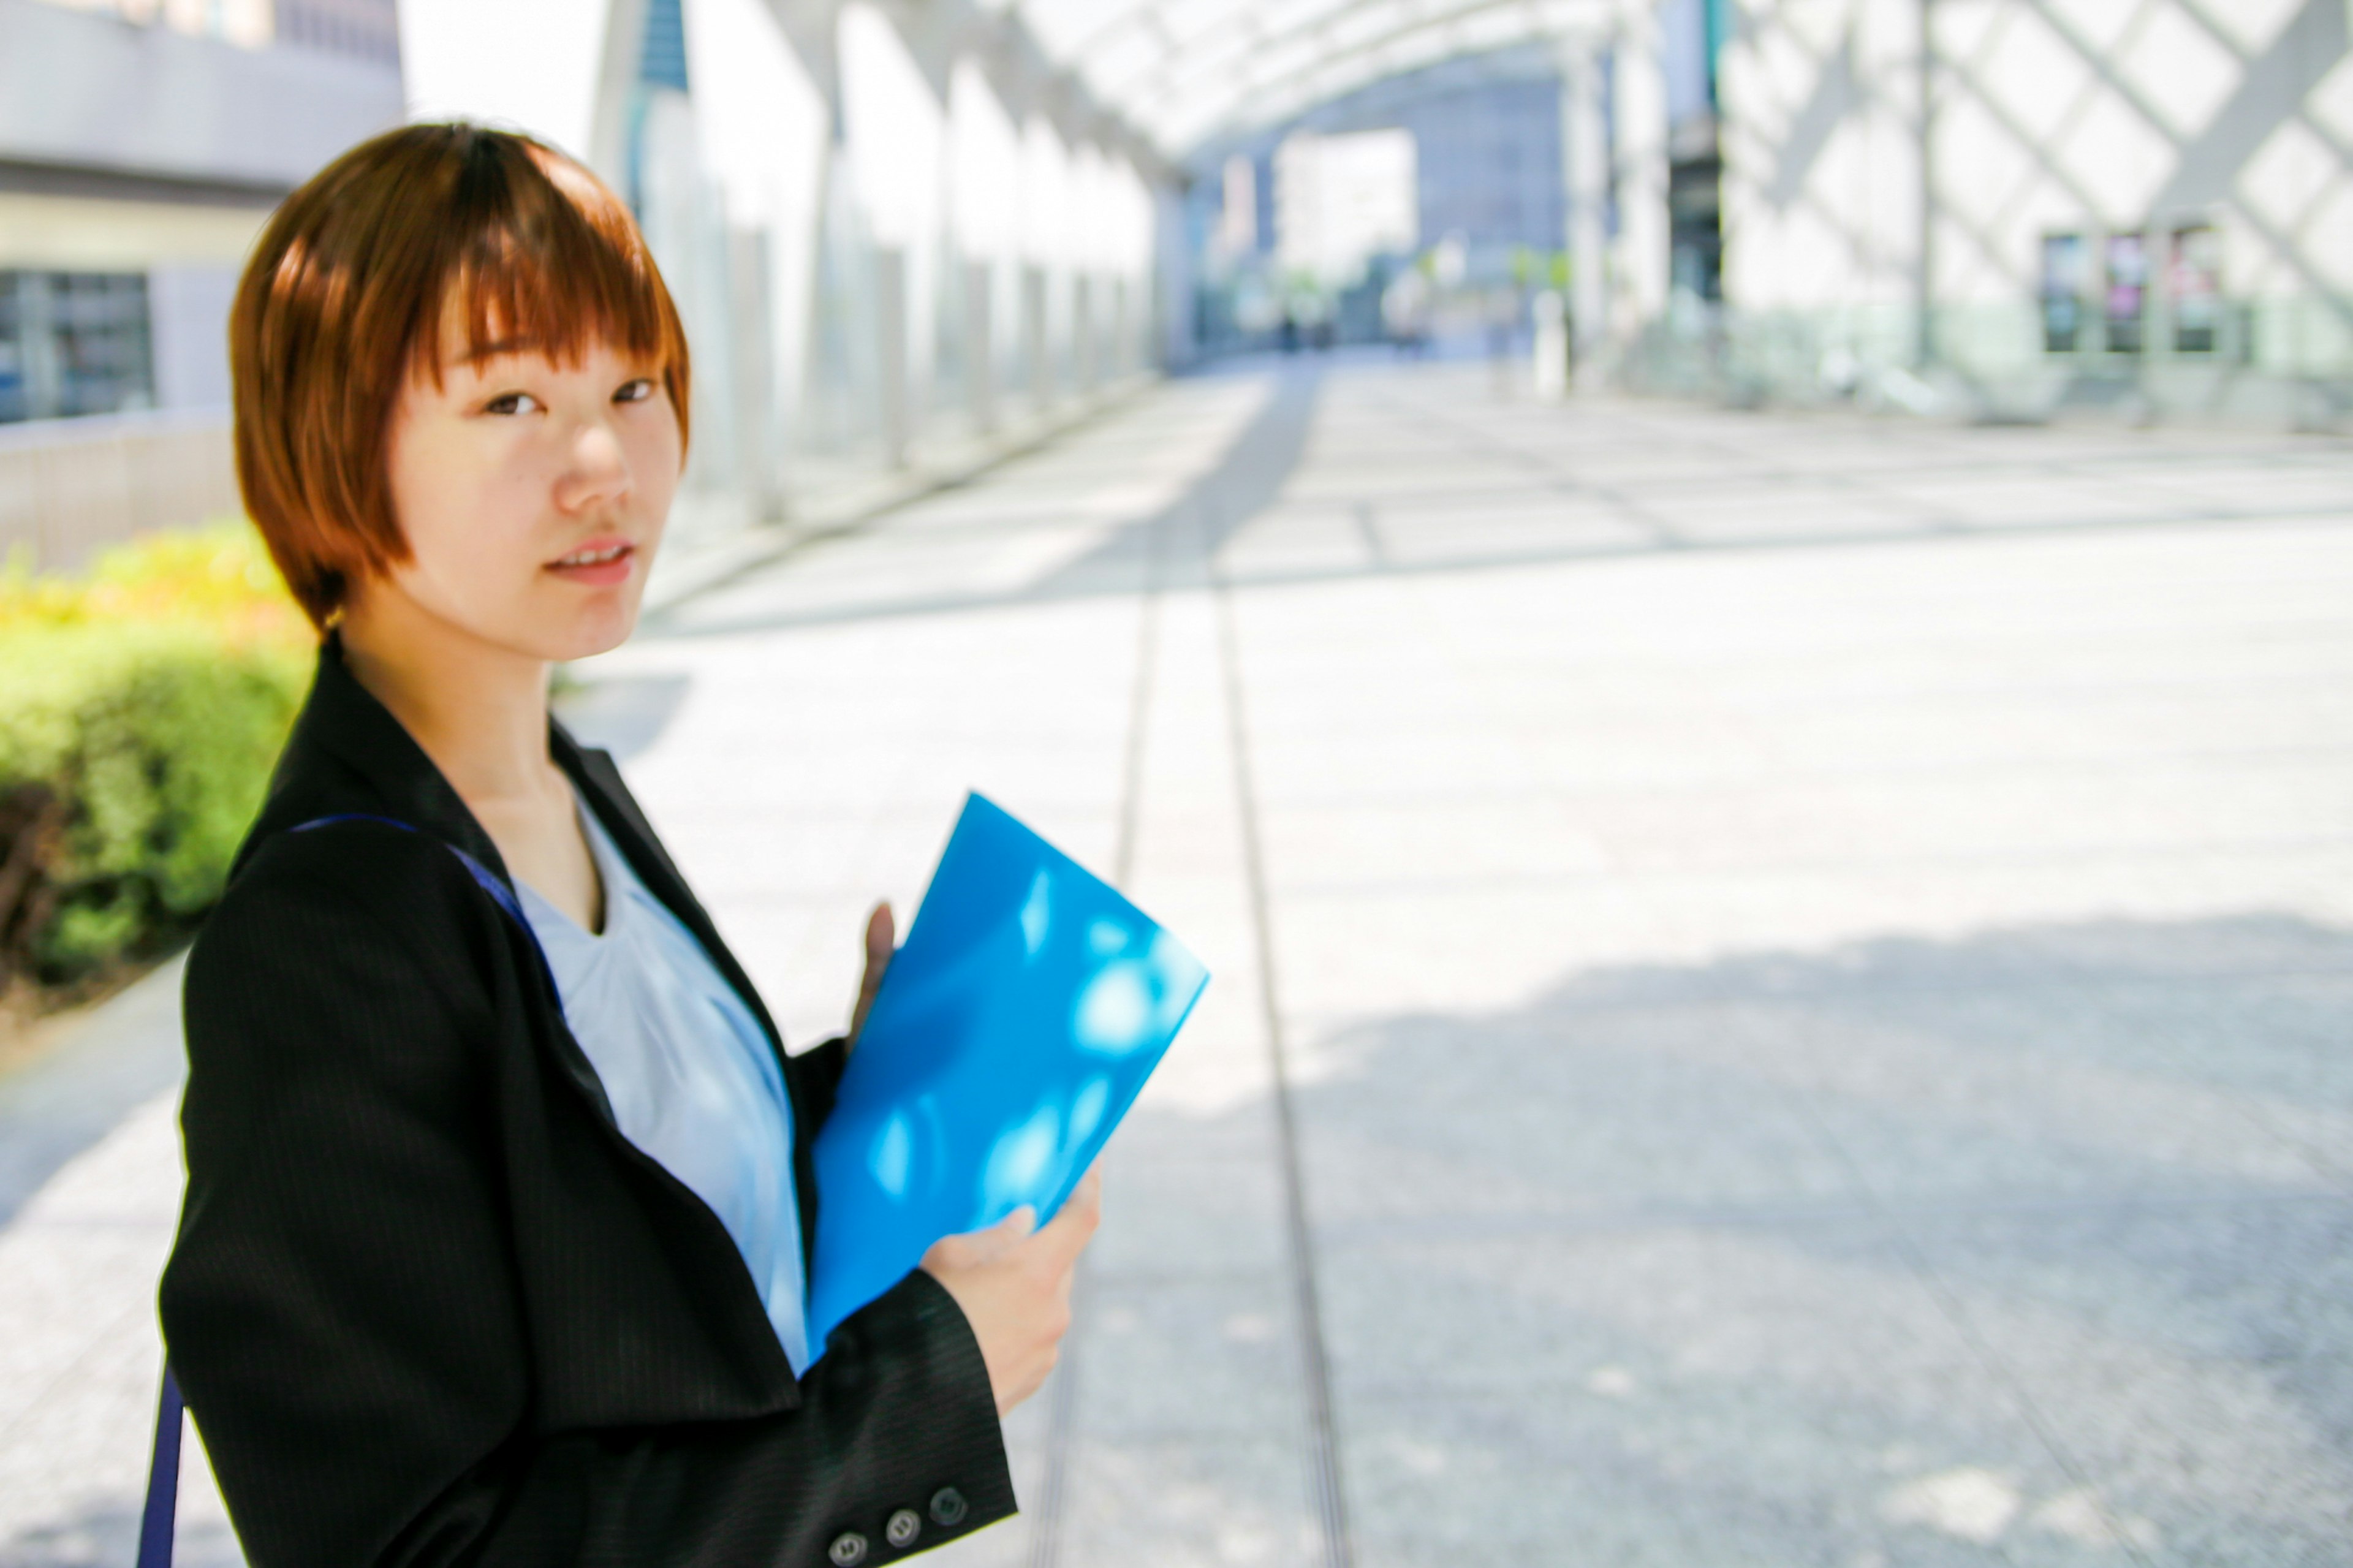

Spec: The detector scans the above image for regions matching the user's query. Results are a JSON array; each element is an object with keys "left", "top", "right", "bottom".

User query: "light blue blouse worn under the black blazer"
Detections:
[{"left": 515, "top": 808, "right": 809, "bottom": 1377}]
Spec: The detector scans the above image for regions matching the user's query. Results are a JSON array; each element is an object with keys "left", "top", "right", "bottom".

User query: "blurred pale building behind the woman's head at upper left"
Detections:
[{"left": 0, "top": 0, "right": 400, "bottom": 424}]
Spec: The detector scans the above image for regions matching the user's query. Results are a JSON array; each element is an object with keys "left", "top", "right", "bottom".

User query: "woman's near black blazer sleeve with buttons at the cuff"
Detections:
[{"left": 162, "top": 829, "right": 1012, "bottom": 1568}]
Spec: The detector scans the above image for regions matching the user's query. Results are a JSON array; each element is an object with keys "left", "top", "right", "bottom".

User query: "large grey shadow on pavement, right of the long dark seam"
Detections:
[{"left": 1110, "top": 914, "right": 2353, "bottom": 1568}]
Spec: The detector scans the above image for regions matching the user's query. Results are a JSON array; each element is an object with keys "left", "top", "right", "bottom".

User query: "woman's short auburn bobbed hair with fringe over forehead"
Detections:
[{"left": 228, "top": 125, "right": 687, "bottom": 631}]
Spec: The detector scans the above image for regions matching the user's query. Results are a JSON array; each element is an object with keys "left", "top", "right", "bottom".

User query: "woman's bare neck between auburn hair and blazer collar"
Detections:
[{"left": 341, "top": 584, "right": 565, "bottom": 822}]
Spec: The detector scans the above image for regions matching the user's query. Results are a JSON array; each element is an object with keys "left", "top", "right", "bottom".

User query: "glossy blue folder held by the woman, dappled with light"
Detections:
[{"left": 809, "top": 796, "right": 1210, "bottom": 1354}]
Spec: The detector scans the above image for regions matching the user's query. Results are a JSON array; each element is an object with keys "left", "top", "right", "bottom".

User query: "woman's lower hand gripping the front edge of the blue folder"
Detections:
[{"left": 922, "top": 1170, "right": 1104, "bottom": 1415}]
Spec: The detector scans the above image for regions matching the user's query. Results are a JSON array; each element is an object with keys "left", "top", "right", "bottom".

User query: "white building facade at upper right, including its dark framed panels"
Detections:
[{"left": 1722, "top": 0, "right": 2353, "bottom": 424}]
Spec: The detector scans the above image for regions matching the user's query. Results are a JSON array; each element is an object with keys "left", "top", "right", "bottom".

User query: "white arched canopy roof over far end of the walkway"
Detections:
[{"left": 1012, "top": 0, "right": 1616, "bottom": 157}]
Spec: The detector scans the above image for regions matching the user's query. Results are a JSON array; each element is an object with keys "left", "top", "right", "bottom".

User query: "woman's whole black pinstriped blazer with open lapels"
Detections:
[{"left": 162, "top": 638, "right": 1014, "bottom": 1568}]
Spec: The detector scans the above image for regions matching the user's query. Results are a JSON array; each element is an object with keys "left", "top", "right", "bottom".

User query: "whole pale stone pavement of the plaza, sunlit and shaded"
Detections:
[{"left": 0, "top": 360, "right": 2353, "bottom": 1568}]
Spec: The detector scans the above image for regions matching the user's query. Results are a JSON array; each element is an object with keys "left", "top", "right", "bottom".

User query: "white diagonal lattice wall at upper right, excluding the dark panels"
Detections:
[{"left": 1722, "top": 0, "right": 2353, "bottom": 403}]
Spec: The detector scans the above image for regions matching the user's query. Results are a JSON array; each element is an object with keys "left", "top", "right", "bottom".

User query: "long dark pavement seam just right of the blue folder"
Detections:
[{"left": 1207, "top": 553, "right": 1355, "bottom": 1568}]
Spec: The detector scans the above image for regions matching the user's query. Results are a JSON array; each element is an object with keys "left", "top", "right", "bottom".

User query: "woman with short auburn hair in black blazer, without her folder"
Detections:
[{"left": 162, "top": 125, "right": 1096, "bottom": 1568}]
